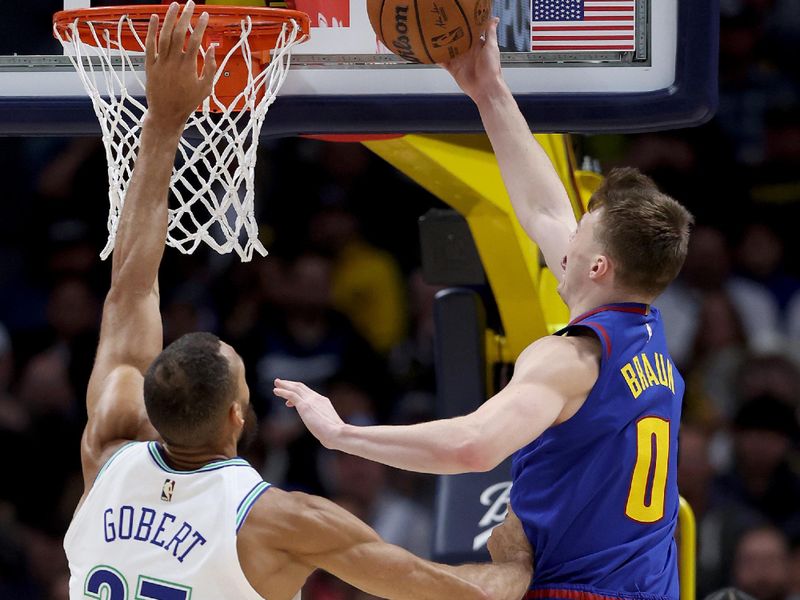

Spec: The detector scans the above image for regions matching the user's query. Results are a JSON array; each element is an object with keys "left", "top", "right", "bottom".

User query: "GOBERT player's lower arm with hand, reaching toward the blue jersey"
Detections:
[{"left": 239, "top": 489, "right": 533, "bottom": 600}]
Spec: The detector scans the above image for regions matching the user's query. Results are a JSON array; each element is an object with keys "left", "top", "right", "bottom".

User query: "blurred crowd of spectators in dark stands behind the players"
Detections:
[{"left": 0, "top": 0, "right": 800, "bottom": 600}]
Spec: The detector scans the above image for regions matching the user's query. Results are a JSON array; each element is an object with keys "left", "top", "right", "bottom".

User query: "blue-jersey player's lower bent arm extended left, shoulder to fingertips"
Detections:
[{"left": 274, "top": 337, "right": 600, "bottom": 474}]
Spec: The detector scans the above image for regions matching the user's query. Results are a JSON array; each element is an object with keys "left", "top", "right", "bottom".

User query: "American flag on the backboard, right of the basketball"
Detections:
[{"left": 531, "top": 0, "right": 636, "bottom": 52}]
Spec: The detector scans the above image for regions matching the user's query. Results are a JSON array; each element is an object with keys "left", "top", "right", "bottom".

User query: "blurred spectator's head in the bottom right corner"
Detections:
[{"left": 733, "top": 526, "right": 789, "bottom": 600}]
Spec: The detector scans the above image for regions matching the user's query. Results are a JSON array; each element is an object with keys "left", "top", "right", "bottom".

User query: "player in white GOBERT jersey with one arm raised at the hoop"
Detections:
[{"left": 64, "top": 3, "right": 531, "bottom": 600}]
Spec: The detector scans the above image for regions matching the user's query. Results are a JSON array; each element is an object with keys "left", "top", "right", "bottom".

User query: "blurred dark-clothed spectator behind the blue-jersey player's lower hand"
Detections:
[{"left": 242, "top": 253, "right": 392, "bottom": 493}]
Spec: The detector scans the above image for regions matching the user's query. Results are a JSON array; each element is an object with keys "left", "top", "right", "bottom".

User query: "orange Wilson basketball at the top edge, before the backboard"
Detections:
[{"left": 367, "top": 0, "right": 492, "bottom": 64}]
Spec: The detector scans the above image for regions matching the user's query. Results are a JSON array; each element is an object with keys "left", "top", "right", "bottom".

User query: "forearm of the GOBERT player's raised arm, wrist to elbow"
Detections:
[{"left": 111, "top": 116, "right": 183, "bottom": 294}]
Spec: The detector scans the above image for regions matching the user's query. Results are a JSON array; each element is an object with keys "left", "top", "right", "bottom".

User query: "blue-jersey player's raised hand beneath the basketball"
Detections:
[{"left": 442, "top": 17, "right": 503, "bottom": 102}]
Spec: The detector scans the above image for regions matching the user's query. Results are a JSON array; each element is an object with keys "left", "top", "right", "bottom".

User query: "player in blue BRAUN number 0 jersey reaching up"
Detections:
[{"left": 275, "top": 17, "right": 692, "bottom": 600}]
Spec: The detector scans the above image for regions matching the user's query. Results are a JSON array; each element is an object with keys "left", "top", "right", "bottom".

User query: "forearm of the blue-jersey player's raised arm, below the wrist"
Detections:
[{"left": 475, "top": 80, "right": 574, "bottom": 241}]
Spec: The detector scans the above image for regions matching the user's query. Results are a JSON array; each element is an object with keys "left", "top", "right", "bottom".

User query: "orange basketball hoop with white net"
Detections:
[{"left": 53, "top": 5, "right": 309, "bottom": 261}]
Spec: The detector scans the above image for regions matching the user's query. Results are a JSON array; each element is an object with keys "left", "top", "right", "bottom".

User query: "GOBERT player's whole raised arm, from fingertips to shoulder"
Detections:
[{"left": 81, "top": 2, "right": 216, "bottom": 489}]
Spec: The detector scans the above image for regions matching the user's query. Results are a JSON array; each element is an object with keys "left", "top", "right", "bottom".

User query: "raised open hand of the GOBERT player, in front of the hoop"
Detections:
[{"left": 145, "top": 0, "right": 217, "bottom": 126}]
